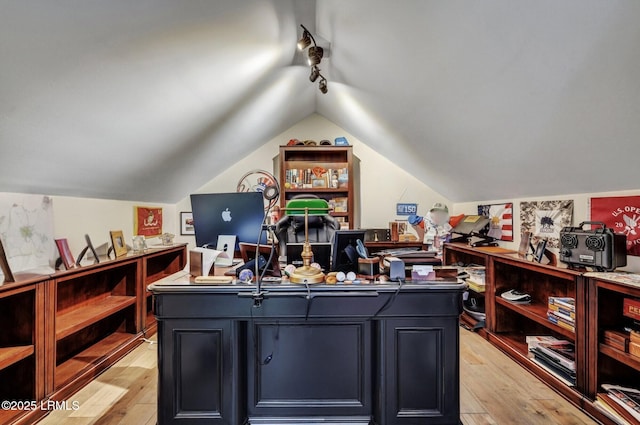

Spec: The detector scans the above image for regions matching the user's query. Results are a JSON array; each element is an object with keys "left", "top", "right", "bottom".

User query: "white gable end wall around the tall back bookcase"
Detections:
[{"left": 176, "top": 114, "right": 451, "bottom": 245}]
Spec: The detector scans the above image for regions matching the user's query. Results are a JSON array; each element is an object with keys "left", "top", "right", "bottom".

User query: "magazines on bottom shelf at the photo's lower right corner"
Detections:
[{"left": 595, "top": 384, "right": 640, "bottom": 424}]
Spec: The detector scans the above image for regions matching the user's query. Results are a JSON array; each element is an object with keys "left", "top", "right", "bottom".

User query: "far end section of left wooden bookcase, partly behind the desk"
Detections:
[{"left": 140, "top": 245, "right": 187, "bottom": 336}]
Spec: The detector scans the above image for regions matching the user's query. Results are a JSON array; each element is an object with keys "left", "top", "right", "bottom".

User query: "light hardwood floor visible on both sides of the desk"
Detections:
[{"left": 40, "top": 329, "right": 595, "bottom": 425}]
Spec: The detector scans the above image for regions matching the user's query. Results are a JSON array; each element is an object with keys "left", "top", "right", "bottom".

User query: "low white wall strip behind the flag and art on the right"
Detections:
[{"left": 453, "top": 190, "right": 640, "bottom": 272}]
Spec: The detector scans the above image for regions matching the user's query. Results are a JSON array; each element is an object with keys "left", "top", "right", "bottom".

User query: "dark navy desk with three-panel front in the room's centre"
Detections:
[{"left": 149, "top": 272, "right": 466, "bottom": 425}]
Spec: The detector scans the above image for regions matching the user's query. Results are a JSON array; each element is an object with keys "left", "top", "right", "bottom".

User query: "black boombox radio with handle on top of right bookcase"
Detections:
[{"left": 560, "top": 221, "right": 627, "bottom": 271}]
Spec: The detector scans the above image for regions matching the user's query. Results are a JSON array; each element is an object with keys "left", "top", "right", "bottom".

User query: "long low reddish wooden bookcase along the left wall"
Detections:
[{"left": 0, "top": 244, "right": 187, "bottom": 424}]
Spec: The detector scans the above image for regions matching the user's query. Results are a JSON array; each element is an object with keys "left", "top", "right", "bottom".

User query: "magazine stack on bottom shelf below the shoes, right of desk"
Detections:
[{"left": 527, "top": 336, "right": 576, "bottom": 387}]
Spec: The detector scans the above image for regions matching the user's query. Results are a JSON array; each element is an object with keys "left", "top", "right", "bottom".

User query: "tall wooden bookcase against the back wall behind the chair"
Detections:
[{"left": 278, "top": 146, "right": 359, "bottom": 229}]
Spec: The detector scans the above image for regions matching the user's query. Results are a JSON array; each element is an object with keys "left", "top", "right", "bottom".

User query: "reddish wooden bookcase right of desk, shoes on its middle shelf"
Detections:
[{"left": 443, "top": 243, "right": 590, "bottom": 408}]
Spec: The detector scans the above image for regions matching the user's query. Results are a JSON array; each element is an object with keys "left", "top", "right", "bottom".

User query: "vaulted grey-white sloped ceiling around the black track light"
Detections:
[{"left": 0, "top": 0, "right": 640, "bottom": 203}]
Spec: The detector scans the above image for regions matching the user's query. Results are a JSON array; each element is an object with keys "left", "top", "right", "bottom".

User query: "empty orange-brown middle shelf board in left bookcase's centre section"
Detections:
[{"left": 56, "top": 296, "right": 136, "bottom": 340}]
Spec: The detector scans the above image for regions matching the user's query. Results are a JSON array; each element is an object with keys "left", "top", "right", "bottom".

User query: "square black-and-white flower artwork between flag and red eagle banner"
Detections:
[{"left": 520, "top": 201, "right": 573, "bottom": 248}]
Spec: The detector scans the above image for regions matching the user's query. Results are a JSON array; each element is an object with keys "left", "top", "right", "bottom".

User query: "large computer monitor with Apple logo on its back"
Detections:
[{"left": 191, "top": 192, "right": 267, "bottom": 251}]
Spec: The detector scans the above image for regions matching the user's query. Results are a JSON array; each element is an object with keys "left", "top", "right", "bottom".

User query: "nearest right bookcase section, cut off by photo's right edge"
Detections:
[{"left": 586, "top": 277, "right": 640, "bottom": 424}]
